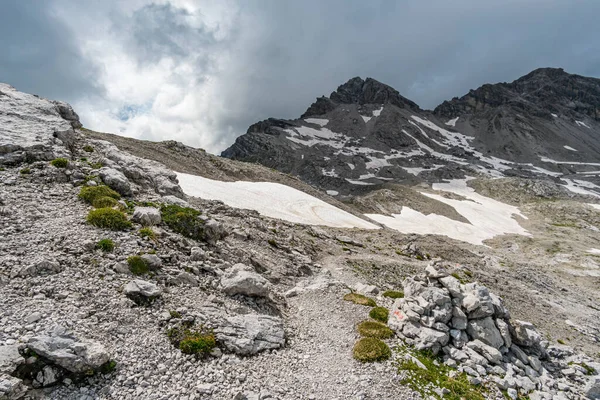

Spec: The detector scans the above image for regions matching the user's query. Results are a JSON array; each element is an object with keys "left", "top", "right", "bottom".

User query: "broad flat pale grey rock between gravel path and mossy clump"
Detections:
[{"left": 215, "top": 314, "right": 285, "bottom": 355}]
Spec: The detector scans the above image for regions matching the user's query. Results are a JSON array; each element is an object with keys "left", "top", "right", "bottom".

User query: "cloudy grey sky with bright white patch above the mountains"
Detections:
[{"left": 0, "top": 0, "right": 600, "bottom": 153}]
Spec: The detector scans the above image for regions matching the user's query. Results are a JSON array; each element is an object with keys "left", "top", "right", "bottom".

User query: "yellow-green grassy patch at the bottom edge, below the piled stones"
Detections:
[{"left": 398, "top": 348, "right": 486, "bottom": 400}]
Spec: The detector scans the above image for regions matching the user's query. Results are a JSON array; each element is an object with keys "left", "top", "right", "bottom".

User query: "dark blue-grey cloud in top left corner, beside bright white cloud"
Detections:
[{"left": 0, "top": 0, "right": 101, "bottom": 101}]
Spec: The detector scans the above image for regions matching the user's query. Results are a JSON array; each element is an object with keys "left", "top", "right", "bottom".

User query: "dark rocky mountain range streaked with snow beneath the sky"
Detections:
[{"left": 222, "top": 69, "right": 600, "bottom": 195}]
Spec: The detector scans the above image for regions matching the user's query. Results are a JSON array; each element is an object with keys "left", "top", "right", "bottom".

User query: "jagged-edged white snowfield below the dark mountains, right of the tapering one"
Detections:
[{"left": 366, "top": 179, "right": 530, "bottom": 245}]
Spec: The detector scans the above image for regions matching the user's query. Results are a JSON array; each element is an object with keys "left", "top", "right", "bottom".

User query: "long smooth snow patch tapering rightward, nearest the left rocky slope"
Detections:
[{"left": 177, "top": 173, "right": 379, "bottom": 229}]
